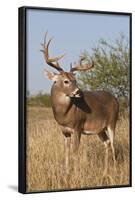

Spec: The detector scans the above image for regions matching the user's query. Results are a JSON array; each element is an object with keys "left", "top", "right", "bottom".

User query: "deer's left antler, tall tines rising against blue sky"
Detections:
[{"left": 40, "top": 32, "right": 65, "bottom": 71}]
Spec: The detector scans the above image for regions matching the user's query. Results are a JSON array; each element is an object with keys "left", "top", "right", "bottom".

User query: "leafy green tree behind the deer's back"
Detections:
[{"left": 77, "top": 34, "right": 130, "bottom": 99}]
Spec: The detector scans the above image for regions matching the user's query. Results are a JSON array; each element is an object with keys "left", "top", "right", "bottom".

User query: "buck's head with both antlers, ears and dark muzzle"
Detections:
[{"left": 41, "top": 32, "right": 94, "bottom": 97}]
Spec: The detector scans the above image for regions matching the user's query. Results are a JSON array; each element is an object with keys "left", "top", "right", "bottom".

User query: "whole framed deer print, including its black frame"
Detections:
[{"left": 19, "top": 7, "right": 132, "bottom": 193}]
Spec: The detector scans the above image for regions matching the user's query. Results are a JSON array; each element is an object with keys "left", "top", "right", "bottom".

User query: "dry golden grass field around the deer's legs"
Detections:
[{"left": 27, "top": 107, "right": 130, "bottom": 192}]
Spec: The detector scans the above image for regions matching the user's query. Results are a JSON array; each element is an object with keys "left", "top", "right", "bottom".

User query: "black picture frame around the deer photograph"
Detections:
[{"left": 18, "top": 6, "right": 132, "bottom": 194}]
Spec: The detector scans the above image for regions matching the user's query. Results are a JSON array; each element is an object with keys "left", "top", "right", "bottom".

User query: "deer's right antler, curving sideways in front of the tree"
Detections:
[{"left": 70, "top": 58, "right": 94, "bottom": 72}]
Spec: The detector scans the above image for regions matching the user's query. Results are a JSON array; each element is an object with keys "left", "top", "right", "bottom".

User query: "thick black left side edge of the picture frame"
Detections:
[{"left": 18, "top": 7, "right": 26, "bottom": 194}]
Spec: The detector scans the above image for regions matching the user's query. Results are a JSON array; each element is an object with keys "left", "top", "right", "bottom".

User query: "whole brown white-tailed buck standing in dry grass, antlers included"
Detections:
[{"left": 41, "top": 33, "right": 119, "bottom": 175}]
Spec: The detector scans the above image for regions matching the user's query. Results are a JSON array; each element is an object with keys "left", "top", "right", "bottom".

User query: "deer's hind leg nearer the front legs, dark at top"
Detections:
[{"left": 98, "top": 131, "right": 110, "bottom": 175}]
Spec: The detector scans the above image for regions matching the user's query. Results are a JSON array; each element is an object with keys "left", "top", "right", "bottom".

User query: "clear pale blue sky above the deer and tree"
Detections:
[{"left": 26, "top": 9, "right": 130, "bottom": 94}]
